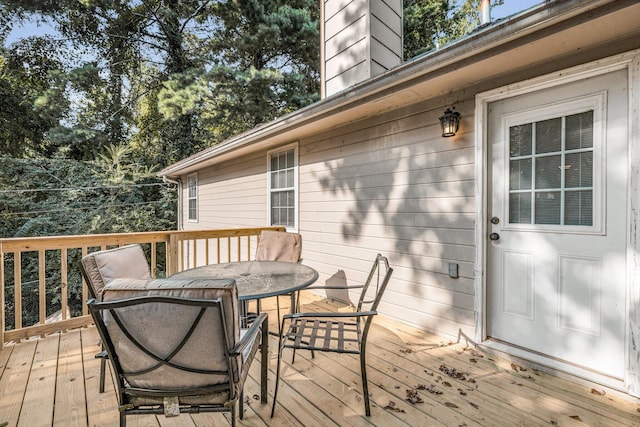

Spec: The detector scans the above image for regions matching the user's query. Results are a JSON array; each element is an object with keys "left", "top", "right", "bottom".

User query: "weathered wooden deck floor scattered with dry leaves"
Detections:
[{"left": 0, "top": 294, "right": 640, "bottom": 427}]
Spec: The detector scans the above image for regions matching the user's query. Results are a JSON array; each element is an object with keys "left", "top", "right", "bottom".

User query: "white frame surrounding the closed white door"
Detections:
[{"left": 474, "top": 50, "right": 640, "bottom": 397}]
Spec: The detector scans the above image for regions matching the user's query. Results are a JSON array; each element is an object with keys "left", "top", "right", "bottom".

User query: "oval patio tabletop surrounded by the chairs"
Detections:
[{"left": 171, "top": 261, "right": 318, "bottom": 300}]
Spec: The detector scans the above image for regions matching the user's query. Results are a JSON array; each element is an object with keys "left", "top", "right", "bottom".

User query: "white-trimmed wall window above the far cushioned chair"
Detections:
[{"left": 268, "top": 145, "right": 298, "bottom": 230}]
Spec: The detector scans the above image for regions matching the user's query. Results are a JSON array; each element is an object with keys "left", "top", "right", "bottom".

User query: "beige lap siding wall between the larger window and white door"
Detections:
[{"left": 300, "top": 101, "right": 475, "bottom": 337}]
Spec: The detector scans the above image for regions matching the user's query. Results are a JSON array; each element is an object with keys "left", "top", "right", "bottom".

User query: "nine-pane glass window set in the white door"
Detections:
[{"left": 509, "top": 111, "right": 593, "bottom": 226}]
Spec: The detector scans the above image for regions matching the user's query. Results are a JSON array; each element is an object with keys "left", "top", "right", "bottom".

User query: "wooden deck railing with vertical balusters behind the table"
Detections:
[{"left": 0, "top": 227, "right": 284, "bottom": 350}]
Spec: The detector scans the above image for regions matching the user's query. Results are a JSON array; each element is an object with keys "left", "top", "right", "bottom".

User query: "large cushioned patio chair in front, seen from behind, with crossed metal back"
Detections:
[{"left": 88, "top": 279, "right": 268, "bottom": 426}]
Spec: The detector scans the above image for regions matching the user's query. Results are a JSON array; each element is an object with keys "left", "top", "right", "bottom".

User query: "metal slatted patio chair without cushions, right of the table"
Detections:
[{"left": 271, "top": 254, "right": 393, "bottom": 417}]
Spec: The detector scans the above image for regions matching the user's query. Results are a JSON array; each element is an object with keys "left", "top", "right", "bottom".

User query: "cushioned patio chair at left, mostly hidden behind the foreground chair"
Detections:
[{"left": 80, "top": 245, "right": 151, "bottom": 393}]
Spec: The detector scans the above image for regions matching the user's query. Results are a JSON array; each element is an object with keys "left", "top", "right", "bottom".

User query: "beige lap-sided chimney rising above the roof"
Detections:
[{"left": 320, "top": 0, "right": 402, "bottom": 98}]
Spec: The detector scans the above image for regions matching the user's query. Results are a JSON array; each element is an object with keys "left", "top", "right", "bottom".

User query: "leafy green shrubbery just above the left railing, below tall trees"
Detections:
[{"left": 0, "top": 155, "right": 176, "bottom": 238}]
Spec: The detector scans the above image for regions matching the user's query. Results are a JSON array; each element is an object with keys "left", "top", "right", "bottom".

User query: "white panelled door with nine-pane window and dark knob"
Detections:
[{"left": 487, "top": 71, "right": 628, "bottom": 378}]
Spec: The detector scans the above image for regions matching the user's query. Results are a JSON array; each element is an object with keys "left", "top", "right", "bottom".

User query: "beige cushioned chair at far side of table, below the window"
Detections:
[{"left": 255, "top": 230, "right": 302, "bottom": 322}]
